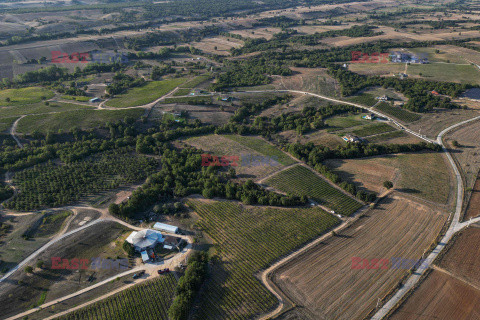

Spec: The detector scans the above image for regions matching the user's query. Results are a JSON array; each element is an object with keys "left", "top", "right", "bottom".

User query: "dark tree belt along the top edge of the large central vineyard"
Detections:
[{"left": 110, "top": 141, "right": 306, "bottom": 217}]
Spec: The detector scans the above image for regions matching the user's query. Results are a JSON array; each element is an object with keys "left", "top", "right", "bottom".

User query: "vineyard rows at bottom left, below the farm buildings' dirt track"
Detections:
[{"left": 58, "top": 274, "right": 177, "bottom": 320}]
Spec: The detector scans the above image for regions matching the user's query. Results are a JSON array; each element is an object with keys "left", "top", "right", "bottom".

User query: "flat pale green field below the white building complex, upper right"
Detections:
[{"left": 407, "top": 63, "right": 480, "bottom": 85}]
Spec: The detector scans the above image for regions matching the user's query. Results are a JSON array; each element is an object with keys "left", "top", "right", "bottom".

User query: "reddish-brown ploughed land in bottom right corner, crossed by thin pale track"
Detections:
[{"left": 389, "top": 227, "right": 480, "bottom": 320}]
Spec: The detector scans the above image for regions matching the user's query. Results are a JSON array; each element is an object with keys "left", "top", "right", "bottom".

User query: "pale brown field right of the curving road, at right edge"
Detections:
[{"left": 445, "top": 121, "right": 480, "bottom": 188}]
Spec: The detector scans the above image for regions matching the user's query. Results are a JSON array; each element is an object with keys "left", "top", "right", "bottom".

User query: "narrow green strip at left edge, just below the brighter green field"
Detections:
[{"left": 0, "top": 102, "right": 94, "bottom": 118}]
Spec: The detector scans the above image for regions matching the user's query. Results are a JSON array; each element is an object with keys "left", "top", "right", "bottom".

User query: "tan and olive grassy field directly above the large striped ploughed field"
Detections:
[{"left": 324, "top": 153, "right": 452, "bottom": 205}]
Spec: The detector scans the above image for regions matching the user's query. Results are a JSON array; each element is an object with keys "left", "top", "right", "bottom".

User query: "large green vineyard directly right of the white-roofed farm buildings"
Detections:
[{"left": 188, "top": 200, "right": 339, "bottom": 320}]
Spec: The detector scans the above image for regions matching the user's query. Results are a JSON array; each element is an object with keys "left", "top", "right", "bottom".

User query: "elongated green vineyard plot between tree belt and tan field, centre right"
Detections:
[{"left": 265, "top": 165, "right": 362, "bottom": 216}]
